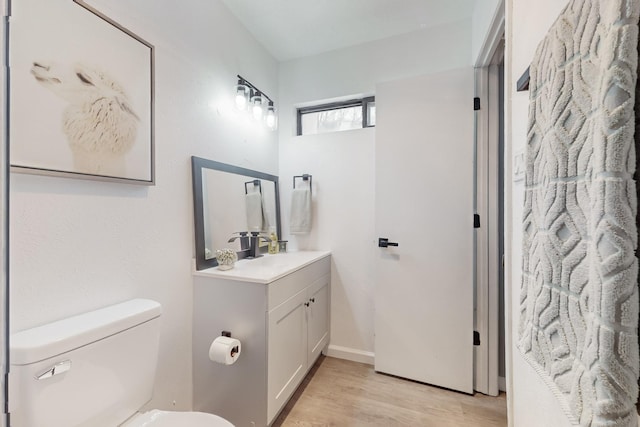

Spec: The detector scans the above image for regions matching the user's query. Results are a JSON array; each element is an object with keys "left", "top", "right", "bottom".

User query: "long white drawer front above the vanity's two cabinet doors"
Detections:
[{"left": 267, "top": 256, "right": 331, "bottom": 311}]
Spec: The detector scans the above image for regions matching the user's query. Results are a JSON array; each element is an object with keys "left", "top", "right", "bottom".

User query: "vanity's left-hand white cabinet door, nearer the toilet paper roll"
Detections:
[{"left": 267, "top": 289, "right": 308, "bottom": 423}]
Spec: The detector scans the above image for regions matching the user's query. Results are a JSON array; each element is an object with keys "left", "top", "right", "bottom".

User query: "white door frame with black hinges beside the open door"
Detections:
[{"left": 474, "top": 0, "right": 505, "bottom": 396}]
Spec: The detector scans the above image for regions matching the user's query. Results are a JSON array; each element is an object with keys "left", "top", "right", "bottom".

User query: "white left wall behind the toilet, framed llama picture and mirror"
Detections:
[{"left": 10, "top": 0, "right": 278, "bottom": 409}]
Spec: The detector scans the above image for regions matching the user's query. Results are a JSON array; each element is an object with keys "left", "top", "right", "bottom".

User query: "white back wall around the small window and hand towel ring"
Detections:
[{"left": 279, "top": 21, "right": 472, "bottom": 363}]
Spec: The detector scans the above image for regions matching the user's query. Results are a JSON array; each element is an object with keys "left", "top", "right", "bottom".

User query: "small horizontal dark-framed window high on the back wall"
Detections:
[{"left": 298, "top": 96, "right": 376, "bottom": 135}]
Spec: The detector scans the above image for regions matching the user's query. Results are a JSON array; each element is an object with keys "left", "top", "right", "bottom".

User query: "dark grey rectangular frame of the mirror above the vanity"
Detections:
[{"left": 191, "top": 156, "right": 282, "bottom": 270}]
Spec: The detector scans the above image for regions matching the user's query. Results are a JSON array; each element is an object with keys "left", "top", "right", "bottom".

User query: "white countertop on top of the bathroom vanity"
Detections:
[{"left": 193, "top": 251, "right": 331, "bottom": 284}]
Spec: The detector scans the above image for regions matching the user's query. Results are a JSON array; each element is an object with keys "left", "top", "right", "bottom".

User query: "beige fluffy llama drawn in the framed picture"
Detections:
[{"left": 31, "top": 61, "right": 140, "bottom": 176}]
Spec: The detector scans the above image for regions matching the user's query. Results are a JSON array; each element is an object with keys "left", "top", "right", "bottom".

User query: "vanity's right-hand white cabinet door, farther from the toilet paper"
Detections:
[{"left": 307, "top": 275, "right": 330, "bottom": 366}]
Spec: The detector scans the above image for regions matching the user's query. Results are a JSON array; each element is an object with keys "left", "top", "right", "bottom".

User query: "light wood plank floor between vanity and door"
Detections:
[{"left": 273, "top": 356, "right": 507, "bottom": 427}]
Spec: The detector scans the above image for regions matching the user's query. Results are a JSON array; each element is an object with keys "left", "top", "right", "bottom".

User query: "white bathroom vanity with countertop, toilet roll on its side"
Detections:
[{"left": 193, "top": 251, "right": 331, "bottom": 427}]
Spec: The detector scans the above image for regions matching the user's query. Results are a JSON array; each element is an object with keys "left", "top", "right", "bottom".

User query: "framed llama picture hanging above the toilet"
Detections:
[{"left": 9, "top": 0, "right": 155, "bottom": 185}]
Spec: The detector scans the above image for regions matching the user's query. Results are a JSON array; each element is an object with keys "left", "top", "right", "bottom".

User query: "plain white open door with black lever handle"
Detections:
[{"left": 375, "top": 68, "right": 473, "bottom": 393}]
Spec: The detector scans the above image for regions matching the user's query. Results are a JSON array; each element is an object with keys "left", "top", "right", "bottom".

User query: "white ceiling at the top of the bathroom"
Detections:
[{"left": 222, "top": 0, "right": 476, "bottom": 61}]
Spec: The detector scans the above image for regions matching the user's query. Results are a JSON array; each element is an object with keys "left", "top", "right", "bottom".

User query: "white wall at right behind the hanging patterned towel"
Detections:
[{"left": 505, "top": 0, "right": 570, "bottom": 427}]
